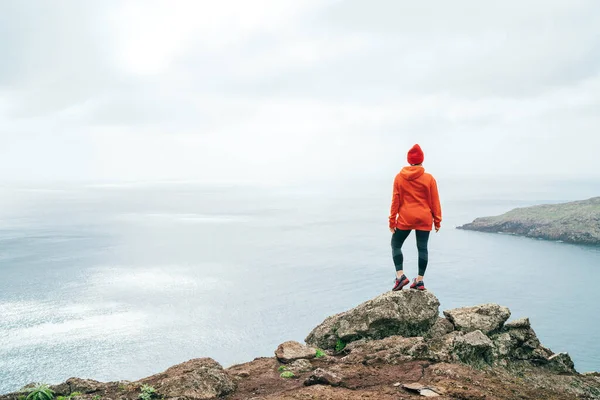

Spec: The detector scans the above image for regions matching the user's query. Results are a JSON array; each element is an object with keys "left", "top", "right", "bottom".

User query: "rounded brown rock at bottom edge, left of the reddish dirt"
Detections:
[{"left": 139, "top": 358, "right": 236, "bottom": 400}]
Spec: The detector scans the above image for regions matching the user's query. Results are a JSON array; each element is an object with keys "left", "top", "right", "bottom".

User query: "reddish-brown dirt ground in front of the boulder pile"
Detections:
[{"left": 225, "top": 358, "right": 600, "bottom": 400}]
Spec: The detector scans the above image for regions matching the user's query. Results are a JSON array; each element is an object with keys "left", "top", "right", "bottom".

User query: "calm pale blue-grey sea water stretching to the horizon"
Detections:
[{"left": 0, "top": 182, "right": 600, "bottom": 393}]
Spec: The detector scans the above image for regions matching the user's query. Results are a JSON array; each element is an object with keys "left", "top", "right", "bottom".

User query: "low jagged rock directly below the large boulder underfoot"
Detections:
[{"left": 341, "top": 336, "right": 427, "bottom": 364}]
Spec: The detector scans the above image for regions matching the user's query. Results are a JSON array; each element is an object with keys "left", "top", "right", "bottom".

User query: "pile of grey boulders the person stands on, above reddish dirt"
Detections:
[{"left": 306, "top": 291, "right": 574, "bottom": 372}]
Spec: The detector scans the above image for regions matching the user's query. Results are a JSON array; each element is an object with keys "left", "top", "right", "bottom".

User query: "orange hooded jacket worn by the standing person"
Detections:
[{"left": 390, "top": 166, "right": 442, "bottom": 231}]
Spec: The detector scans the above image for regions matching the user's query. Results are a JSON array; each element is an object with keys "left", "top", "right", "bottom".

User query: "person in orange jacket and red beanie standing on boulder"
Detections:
[{"left": 389, "top": 144, "right": 442, "bottom": 291}]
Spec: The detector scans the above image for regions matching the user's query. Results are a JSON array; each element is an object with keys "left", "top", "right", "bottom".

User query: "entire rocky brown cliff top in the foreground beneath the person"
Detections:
[{"left": 0, "top": 291, "right": 600, "bottom": 400}]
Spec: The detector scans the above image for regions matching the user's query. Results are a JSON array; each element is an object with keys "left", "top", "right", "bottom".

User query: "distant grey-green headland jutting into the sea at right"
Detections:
[{"left": 458, "top": 197, "right": 600, "bottom": 245}]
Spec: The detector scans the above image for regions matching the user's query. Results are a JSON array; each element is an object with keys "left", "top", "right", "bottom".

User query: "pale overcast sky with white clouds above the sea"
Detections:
[{"left": 0, "top": 0, "right": 600, "bottom": 184}]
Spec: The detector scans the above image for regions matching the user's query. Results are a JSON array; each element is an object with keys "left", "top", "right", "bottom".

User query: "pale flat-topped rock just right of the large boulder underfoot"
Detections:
[{"left": 444, "top": 304, "right": 510, "bottom": 334}]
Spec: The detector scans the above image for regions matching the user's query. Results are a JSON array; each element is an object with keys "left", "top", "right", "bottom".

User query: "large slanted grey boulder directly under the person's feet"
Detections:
[{"left": 306, "top": 290, "right": 440, "bottom": 349}]
